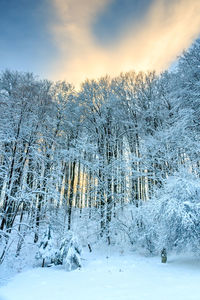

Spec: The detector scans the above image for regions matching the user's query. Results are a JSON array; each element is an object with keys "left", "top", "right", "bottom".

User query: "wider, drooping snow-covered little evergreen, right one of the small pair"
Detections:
[{"left": 55, "top": 231, "right": 81, "bottom": 271}]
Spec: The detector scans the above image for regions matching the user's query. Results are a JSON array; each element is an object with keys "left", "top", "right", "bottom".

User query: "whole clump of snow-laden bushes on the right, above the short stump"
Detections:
[{"left": 118, "top": 168, "right": 200, "bottom": 255}]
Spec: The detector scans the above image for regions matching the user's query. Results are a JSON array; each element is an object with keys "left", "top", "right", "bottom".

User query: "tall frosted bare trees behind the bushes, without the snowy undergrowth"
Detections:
[{"left": 0, "top": 40, "right": 200, "bottom": 261}]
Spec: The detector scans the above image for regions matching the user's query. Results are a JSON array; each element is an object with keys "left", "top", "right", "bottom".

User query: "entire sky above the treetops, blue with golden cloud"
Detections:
[{"left": 0, "top": 0, "right": 200, "bottom": 85}]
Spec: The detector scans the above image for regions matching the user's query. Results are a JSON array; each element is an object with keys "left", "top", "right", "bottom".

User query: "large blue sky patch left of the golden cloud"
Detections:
[{"left": 0, "top": 0, "right": 57, "bottom": 75}]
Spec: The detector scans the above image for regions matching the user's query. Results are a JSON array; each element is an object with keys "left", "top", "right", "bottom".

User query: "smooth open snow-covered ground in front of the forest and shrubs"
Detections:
[{"left": 0, "top": 248, "right": 200, "bottom": 300}]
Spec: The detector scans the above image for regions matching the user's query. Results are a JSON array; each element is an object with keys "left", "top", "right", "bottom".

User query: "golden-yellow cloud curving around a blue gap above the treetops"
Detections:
[{"left": 50, "top": 0, "right": 200, "bottom": 85}]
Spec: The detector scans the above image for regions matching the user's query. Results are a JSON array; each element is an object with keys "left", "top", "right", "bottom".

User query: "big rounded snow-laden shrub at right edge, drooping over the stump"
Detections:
[{"left": 149, "top": 170, "right": 200, "bottom": 253}]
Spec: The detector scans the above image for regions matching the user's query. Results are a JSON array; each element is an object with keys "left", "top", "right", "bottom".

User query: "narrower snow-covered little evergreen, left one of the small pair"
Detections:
[{"left": 36, "top": 226, "right": 56, "bottom": 267}]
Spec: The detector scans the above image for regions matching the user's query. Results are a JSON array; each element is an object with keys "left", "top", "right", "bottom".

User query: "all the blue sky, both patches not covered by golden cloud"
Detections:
[{"left": 0, "top": 0, "right": 151, "bottom": 76}]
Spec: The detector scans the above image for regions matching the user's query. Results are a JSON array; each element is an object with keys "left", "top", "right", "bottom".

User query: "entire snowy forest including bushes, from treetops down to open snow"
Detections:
[{"left": 0, "top": 39, "right": 200, "bottom": 265}]
